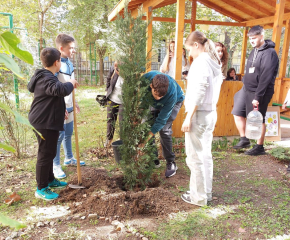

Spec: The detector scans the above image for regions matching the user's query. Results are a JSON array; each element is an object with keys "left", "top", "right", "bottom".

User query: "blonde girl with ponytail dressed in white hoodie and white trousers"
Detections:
[{"left": 181, "top": 31, "right": 223, "bottom": 206}]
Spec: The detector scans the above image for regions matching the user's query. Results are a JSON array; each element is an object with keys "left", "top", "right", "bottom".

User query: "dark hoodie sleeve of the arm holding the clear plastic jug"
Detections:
[{"left": 255, "top": 51, "right": 279, "bottom": 102}]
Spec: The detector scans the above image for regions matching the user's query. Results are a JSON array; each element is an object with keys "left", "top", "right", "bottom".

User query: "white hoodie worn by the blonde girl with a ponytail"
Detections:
[{"left": 185, "top": 52, "right": 223, "bottom": 112}]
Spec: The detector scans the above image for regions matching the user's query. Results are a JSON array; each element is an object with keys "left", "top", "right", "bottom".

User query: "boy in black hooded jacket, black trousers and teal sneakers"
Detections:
[{"left": 27, "top": 48, "right": 78, "bottom": 201}]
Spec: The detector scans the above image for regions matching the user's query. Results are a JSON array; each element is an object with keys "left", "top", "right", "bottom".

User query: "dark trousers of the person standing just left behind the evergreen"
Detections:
[{"left": 107, "top": 100, "right": 123, "bottom": 140}]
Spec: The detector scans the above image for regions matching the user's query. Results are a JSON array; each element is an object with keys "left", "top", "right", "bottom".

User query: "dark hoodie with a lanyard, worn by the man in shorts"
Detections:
[{"left": 242, "top": 40, "right": 279, "bottom": 102}]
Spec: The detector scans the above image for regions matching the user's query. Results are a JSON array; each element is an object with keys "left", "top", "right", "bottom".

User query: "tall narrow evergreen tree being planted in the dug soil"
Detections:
[{"left": 114, "top": 5, "right": 154, "bottom": 188}]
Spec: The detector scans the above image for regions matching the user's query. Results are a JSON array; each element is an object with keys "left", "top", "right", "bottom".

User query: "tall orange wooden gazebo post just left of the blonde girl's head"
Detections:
[{"left": 174, "top": 0, "right": 185, "bottom": 80}]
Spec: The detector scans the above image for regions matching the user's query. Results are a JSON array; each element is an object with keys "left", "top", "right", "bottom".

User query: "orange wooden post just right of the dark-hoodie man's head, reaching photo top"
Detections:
[{"left": 272, "top": 0, "right": 286, "bottom": 54}]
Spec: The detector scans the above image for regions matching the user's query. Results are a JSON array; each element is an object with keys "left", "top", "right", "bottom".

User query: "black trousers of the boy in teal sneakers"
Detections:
[{"left": 35, "top": 129, "right": 59, "bottom": 190}]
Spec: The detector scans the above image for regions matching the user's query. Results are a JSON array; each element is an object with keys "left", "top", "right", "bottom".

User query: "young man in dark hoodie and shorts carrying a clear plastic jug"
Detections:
[{"left": 232, "top": 26, "right": 279, "bottom": 156}]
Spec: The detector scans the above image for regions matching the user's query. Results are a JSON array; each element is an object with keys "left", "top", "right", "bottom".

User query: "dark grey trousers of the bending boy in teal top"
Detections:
[{"left": 150, "top": 102, "right": 182, "bottom": 163}]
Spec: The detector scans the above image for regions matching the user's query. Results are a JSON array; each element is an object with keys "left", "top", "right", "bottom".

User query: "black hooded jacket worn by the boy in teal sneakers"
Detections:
[{"left": 27, "top": 69, "right": 73, "bottom": 131}]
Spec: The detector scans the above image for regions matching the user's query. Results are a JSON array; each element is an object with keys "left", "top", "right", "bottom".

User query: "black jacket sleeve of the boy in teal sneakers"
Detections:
[{"left": 44, "top": 77, "right": 74, "bottom": 97}]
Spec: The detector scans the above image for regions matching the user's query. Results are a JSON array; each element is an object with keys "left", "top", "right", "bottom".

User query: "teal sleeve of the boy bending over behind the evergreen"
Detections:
[{"left": 151, "top": 94, "right": 176, "bottom": 134}]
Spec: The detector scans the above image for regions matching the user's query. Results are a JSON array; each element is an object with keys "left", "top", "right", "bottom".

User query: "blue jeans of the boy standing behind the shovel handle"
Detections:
[{"left": 53, "top": 121, "right": 74, "bottom": 166}]
